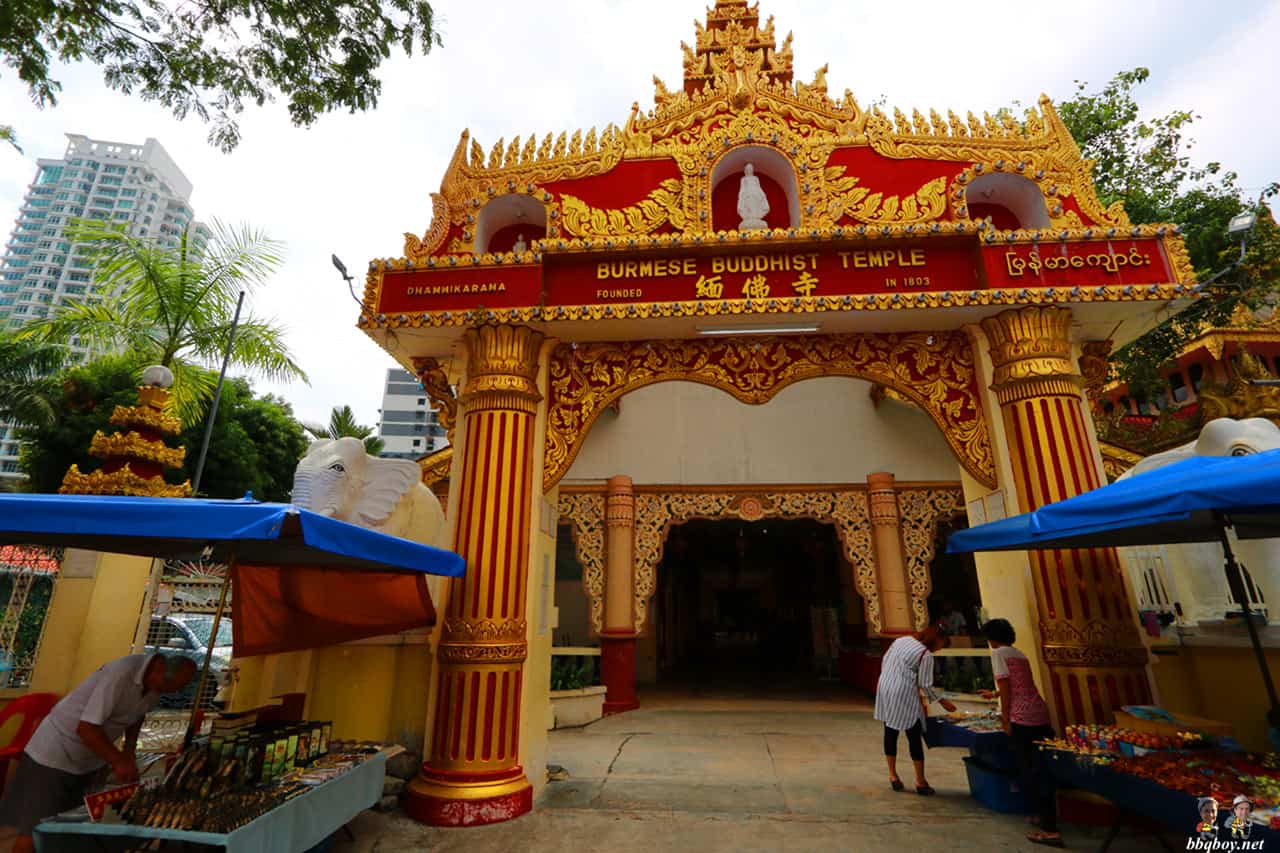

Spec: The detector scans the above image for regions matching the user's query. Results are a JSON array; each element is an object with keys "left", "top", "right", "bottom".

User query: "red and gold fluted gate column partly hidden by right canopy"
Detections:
[{"left": 982, "top": 306, "right": 1151, "bottom": 725}]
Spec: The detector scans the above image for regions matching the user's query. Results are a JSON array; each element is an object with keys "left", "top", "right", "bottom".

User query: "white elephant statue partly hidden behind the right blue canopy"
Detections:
[{"left": 1120, "top": 418, "right": 1280, "bottom": 622}]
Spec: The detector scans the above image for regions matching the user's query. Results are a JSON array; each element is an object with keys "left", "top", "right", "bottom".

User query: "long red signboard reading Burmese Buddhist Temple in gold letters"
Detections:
[{"left": 378, "top": 238, "right": 1174, "bottom": 314}]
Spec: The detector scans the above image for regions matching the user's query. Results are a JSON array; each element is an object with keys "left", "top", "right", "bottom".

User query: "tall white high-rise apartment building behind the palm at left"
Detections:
[{"left": 0, "top": 133, "right": 207, "bottom": 482}]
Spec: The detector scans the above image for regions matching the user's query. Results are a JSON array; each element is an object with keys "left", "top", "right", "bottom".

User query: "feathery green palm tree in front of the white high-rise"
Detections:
[{"left": 19, "top": 222, "right": 306, "bottom": 424}]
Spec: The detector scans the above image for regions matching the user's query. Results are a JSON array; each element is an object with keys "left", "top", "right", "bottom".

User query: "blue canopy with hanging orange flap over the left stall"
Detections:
[{"left": 0, "top": 494, "right": 466, "bottom": 740}]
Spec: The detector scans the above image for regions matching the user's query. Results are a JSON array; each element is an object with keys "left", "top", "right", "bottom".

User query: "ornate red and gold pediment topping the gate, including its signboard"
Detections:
[{"left": 360, "top": 0, "right": 1194, "bottom": 330}]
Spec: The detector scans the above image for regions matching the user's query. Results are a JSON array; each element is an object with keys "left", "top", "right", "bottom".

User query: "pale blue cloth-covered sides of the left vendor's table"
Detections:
[{"left": 36, "top": 753, "right": 387, "bottom": 853}]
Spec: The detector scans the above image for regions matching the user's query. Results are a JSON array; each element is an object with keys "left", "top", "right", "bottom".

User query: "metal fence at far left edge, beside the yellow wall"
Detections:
[{"left": 0, "top": 546, "right": 63, "bottom": 688}]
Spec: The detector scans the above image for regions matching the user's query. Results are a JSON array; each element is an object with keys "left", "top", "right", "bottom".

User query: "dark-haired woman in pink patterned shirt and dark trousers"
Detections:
[{"left": 982, "top": 619, "right": 1062, "bottom": 847}]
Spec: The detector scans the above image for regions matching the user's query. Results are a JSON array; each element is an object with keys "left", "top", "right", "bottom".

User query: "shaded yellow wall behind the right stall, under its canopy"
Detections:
[{"left": 1151, "top": 646, "right": 1280, "bottom": 752}]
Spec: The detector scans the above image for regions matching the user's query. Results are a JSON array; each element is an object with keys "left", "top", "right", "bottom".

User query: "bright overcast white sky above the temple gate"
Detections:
[{"left": 0, "top": 0, "right": 1280, "bottom": 423}]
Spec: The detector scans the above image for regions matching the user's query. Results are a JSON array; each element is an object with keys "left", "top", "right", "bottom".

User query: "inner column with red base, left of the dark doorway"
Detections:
[{"left": 600, "top": 476, "right": 640, "bottom": 713}]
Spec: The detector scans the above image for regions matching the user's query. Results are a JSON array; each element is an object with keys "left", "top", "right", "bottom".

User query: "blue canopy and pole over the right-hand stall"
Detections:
[{"left": 947, "top": 450, "right": 1280, "bottom": 729}]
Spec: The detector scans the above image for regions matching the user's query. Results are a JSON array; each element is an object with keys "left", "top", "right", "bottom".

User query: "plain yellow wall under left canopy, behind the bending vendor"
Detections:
[{"left": 31, "top": 551, "right": 151, "bottom": 694}]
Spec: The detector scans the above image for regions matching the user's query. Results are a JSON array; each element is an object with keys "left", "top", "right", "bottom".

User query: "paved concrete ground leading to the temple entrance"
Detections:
[{"left": 334, "top": 693, "right": 1185, "bottom": 853}]
